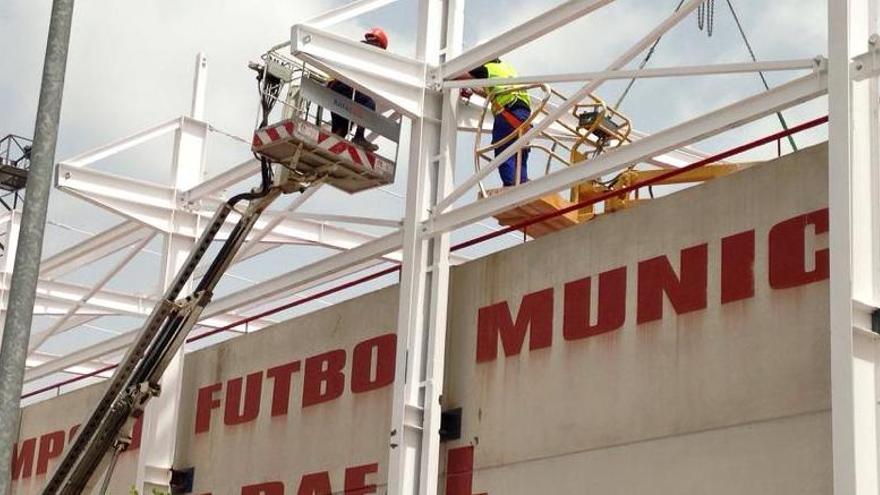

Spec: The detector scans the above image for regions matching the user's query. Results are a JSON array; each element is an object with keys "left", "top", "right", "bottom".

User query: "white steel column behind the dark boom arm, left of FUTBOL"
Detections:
[{"left": 136, "top": 53, "right": 208, "bottom": 493}]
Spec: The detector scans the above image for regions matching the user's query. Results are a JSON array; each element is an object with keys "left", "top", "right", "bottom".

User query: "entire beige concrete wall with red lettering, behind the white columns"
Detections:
[{"left": 16, "top": 147, "right": 836, "bottom": 495}]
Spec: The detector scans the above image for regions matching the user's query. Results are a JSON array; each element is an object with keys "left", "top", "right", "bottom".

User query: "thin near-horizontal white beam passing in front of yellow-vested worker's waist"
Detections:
[{"left": 443, "top": 59, "right": 817, "bottom": 88}]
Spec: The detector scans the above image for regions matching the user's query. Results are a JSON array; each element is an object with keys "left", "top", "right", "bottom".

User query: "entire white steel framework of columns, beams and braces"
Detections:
[{"left": 6, "top": 0, "right": 880, "bottom": 495}]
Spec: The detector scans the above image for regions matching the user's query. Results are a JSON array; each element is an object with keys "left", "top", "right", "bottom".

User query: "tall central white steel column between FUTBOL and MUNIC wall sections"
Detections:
[{"left": 388, "top": 0, "right": 464, "bottom": 495}]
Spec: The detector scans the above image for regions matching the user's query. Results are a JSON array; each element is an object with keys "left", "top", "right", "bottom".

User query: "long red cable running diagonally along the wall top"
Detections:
[{"left": 21, "top": 115, "right": 828, "bottom": 399}]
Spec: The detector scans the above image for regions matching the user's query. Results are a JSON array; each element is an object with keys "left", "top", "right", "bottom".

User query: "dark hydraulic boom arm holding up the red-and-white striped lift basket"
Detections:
[{"left": 43, "top": 176, "right": 304, "bottom": 495}]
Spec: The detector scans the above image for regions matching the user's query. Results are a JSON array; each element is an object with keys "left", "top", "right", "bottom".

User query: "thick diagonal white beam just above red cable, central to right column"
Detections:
[{"left": 423, "top": 73, "right": 827, "bottom": 236}]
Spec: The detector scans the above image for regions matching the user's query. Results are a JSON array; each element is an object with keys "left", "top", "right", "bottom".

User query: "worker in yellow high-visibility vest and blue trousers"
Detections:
[{"left": 458, "top": 58, "right": 532, "bottom": 187}]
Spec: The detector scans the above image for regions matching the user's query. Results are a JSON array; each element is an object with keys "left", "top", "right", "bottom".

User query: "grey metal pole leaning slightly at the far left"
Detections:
[{"left": 0, "top": 0, "right": 74, "bottom": 494}]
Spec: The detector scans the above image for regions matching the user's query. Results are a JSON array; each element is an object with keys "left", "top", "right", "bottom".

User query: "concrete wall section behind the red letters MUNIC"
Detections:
[{"left": 444, "top": 142, "right": 831, "bottom": 495}]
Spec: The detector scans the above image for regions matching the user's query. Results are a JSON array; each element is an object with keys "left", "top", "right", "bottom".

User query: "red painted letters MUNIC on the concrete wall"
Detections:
[{"left": 477, "top": 209, "right": 829, "bottom": 363}]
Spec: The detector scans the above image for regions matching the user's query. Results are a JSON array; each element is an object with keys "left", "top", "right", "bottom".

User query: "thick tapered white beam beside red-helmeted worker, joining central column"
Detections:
[{"left": 291, "top": 24, "right": 432, "bottom": 118}]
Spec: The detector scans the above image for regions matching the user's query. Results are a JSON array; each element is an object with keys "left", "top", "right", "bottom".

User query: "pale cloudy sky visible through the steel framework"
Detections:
[{"left": 0, "top": 0, "right": 827, "bottom": 396}]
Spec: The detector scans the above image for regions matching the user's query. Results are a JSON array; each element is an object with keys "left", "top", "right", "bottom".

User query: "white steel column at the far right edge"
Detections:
[{"left": 828, "top": 0, "right": 880, "bottom": 495}]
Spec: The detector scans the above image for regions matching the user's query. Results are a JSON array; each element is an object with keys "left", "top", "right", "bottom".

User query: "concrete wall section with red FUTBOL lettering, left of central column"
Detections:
[{"left": 176, "top": 288, "right": 397, "bottom": 495}]
